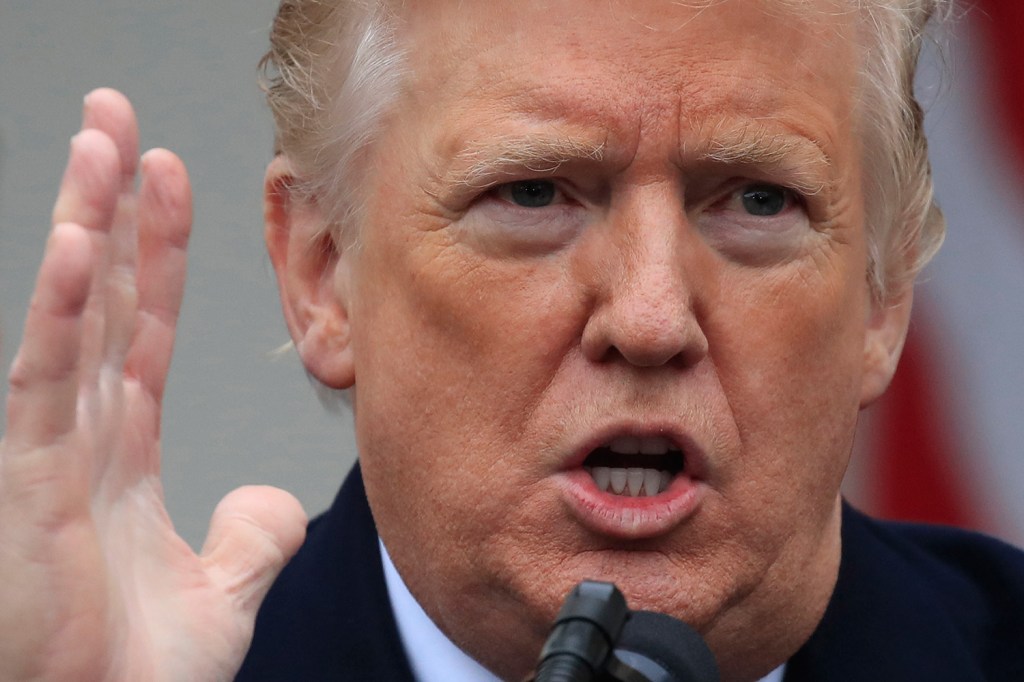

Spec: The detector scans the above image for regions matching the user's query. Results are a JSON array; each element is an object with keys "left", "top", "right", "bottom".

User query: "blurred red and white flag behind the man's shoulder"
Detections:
[{"left": 859, "top": 0, "right": 1024, "bottom": 543}]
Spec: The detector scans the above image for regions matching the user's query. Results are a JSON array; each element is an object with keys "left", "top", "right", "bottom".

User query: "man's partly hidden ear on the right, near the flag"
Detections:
[{"left": 860, "top": 285, "right": 913, "bottom": 408}]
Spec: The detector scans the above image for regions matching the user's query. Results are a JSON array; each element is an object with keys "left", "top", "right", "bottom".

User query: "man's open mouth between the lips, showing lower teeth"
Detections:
[{"left": 583, "top": 436, "right": 685, "bottom": 498}]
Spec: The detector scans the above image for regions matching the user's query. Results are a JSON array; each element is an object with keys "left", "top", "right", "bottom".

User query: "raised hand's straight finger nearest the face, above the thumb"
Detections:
[{"left": 125, "top": 150, "right": 191, "bottom": 402}]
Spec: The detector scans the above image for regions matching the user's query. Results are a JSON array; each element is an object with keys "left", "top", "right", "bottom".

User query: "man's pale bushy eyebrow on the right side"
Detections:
[{"left": 682, "top": 121, "right": 833, "bottom": 195}]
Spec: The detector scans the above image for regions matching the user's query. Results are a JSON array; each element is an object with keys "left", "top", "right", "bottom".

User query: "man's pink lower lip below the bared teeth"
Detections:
[{"left": 557, "top": 468, "right": 705, "bottom": 540}]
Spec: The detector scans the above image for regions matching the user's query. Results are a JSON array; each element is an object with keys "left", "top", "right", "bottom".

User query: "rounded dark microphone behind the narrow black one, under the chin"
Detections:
[{"left": 607, "top": 611, "right": 719, "bottom": 682}]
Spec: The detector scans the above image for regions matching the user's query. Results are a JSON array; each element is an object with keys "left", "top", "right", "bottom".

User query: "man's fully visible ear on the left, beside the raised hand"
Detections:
[{"left": 263, "top": 156, "right": 355, "bottom": 388}]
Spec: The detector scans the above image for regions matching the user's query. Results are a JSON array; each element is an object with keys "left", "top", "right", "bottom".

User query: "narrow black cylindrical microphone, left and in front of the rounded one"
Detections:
[{"left": 534, "top": 581, "right": 630, "bottom": 682}]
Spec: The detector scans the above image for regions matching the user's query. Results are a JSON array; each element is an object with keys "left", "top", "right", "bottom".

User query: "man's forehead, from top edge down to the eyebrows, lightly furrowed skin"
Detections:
[{"left": 395, "top": 0, "right": 858, "bottom": 164}]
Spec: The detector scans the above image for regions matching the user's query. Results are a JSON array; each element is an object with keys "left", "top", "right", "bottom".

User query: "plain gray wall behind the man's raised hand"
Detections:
[{"left": 0, "top": 0, "right": 354, "bottom": 546}]
